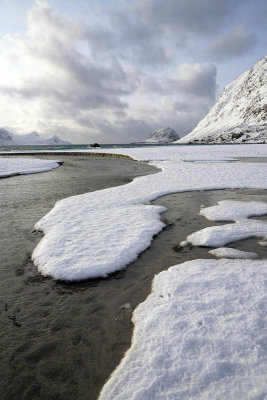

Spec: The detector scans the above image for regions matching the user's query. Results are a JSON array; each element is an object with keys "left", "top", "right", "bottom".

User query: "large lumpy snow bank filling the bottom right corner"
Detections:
[{"left": 99, "top": 260, "right": 267, "bottom": 400}]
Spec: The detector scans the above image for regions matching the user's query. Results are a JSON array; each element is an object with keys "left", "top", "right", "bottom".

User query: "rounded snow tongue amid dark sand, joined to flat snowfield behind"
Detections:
[{"left": 32, "top": 145, "right": 267, "bottom": 280}]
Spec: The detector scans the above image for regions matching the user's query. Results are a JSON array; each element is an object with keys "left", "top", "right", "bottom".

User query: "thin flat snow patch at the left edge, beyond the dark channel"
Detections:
[{"left": 0, "top": 157, "right": 59, "bottom": 178}]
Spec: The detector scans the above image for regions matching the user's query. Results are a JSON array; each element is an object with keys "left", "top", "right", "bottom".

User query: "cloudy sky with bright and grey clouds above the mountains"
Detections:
[{"left": 0, "top": 0, "right": 267, "bottom": 143}]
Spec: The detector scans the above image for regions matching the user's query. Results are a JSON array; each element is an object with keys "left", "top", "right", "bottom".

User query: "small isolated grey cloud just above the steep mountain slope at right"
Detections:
[{"left": 209, "top": 25, "right": 257, "bottom": 60}]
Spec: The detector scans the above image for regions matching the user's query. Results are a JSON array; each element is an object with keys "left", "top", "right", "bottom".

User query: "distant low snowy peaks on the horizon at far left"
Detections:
[{"left": 0, "top": 128, "right": 71, "bottom": 146}]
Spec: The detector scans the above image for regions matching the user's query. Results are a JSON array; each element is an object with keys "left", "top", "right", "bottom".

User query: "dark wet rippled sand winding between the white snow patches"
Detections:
[{"left": 0, "top": 156, "right": 267, "bottom": 400}]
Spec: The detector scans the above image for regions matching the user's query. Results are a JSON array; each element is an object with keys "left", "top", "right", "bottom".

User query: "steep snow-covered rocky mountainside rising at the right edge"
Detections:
[{"left": 178, "top": 56, "right": 267, "bottom": 143}]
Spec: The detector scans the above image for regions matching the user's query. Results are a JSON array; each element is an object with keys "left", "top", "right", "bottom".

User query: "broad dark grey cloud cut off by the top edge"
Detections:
[{"left": 80, "top": 0, "right": 242, "bottom": 68}]
